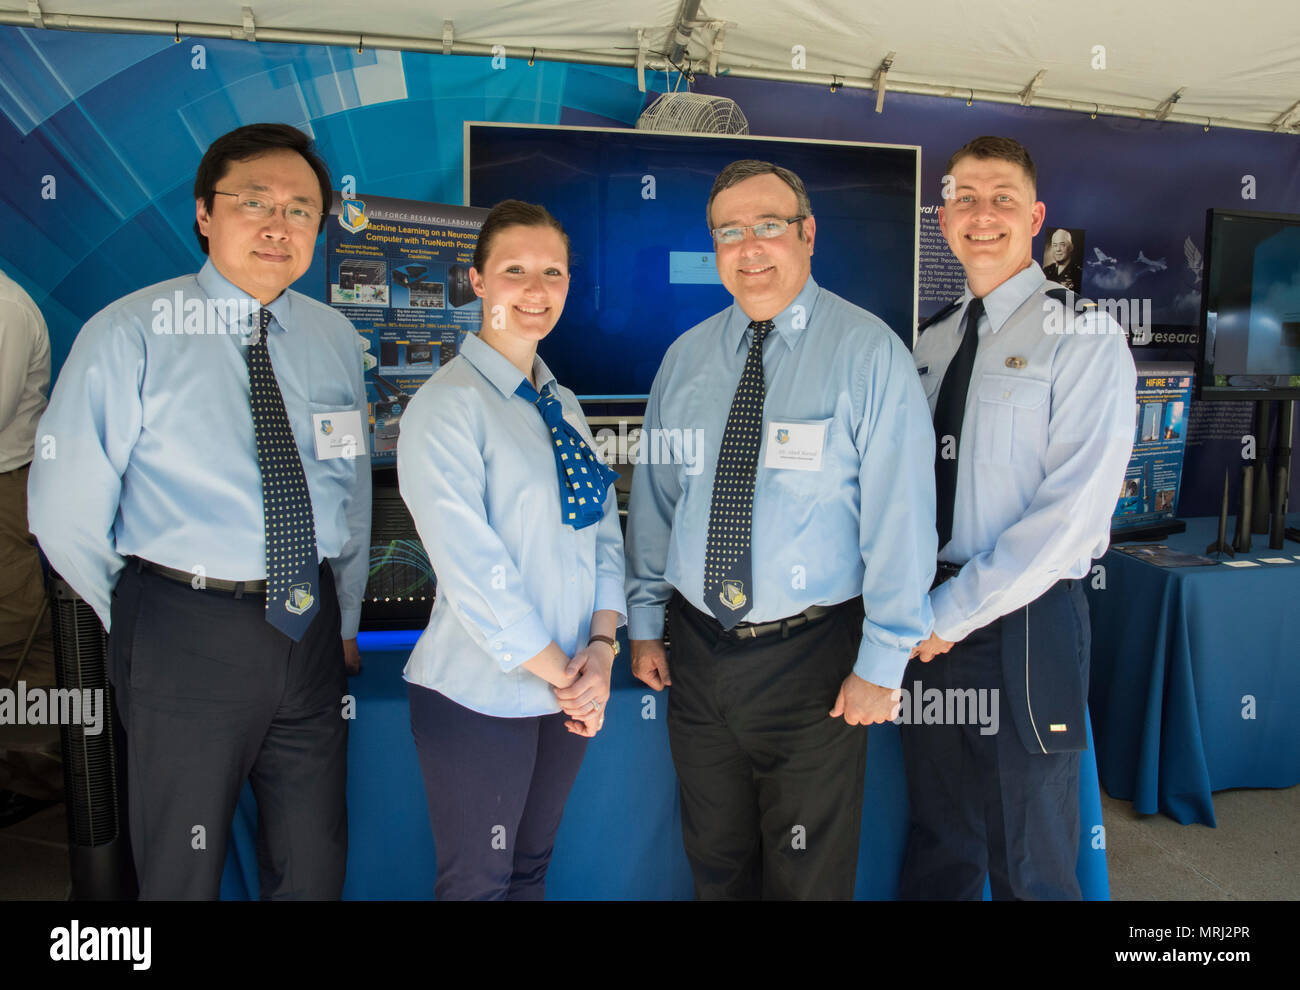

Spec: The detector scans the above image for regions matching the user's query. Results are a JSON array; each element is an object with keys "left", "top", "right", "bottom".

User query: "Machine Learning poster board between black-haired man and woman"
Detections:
[{"left": 325, "top": 192, "right": 488, "bottom": 465}]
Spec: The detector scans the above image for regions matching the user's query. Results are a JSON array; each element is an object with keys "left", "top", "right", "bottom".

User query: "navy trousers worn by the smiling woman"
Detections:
[{"left": 408, "top": 685, "right": 588, "bottom": 900}]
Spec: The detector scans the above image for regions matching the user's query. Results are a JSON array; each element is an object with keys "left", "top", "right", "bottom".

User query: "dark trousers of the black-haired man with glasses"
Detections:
[{"left": 109, "top": 563, "right": 347, "bottom": 900}]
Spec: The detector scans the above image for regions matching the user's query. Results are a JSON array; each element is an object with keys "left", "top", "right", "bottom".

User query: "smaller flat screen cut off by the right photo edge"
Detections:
[{"left": 1196, "top": 209, "right": 1300, "bottom": 400}]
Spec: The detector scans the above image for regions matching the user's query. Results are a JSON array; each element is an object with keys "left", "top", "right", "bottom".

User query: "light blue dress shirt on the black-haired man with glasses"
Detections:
[{"left": 27, "top": 261, "right": 371, "bottom": 639}]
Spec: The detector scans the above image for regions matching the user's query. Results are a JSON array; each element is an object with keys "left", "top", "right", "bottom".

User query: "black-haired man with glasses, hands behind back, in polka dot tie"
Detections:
[{"left": 29, "top": 123, "right": 371, "bottom": 899}]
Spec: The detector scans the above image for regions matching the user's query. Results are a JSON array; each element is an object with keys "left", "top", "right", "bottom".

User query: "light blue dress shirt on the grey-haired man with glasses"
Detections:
[{"left": 628, "top": 277, "right": 937, "bottom": 687}]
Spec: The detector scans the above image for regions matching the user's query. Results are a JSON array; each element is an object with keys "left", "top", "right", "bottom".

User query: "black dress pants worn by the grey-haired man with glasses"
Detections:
[{"left": 668, "top": 595, "right": 867, "bottom": 900}]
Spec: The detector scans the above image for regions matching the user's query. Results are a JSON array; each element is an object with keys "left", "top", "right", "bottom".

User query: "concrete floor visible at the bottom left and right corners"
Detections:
[{"left": 0, "top": 786, "right": 1300, "bottom": 900}]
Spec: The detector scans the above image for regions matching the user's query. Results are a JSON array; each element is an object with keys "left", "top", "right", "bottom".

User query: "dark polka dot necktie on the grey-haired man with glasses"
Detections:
[{"left": 705, "top": 320, "right": 776, "bottom": 629}]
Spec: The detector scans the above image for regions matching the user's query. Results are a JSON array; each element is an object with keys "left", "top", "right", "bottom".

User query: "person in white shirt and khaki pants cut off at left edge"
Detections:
[{"left": 0, "top": 263, "right": 64, "bottom": 828}]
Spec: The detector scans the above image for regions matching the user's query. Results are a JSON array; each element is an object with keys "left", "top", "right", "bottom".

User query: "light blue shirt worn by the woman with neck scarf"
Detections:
[{"left": 398, "top": 334, "right": 627, "bottom": 717}]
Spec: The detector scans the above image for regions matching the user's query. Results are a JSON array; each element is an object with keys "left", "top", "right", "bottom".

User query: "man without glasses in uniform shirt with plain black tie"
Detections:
[{"left": 900, "top": 136, "right": 1136, "bottom": 900}]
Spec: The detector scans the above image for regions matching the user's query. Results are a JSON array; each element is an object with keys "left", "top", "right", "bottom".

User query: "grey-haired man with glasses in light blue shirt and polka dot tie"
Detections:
[{"left": 627, "top": 161, "right": 936, "bottom": 899}]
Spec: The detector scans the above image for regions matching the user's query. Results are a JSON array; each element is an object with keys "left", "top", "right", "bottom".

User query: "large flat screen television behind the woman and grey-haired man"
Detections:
[{"left": 464, "top": 121, "right": 920, "bottom": 403}]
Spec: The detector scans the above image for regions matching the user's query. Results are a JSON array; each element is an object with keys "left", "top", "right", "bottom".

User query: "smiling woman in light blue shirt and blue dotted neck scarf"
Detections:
[{"left": 398, "top": 200, "right": 627, "bottom": 900}]
